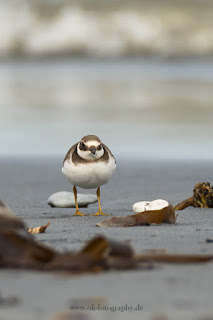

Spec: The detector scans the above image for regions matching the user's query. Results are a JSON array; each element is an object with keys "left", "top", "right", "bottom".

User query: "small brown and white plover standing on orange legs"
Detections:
[{"left": 62, "top": 135, "right": 116, "bottom": 216}]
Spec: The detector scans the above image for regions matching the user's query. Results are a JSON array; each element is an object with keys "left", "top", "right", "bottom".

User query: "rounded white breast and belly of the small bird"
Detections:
[{"left": 62, "top": 156, "right": 116, "bottom": 189}]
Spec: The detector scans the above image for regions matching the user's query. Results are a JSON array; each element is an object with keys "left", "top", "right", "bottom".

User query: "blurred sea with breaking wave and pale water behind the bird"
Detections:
[{"left": 0, "top": 0, "right": 213, "bottom": 160}]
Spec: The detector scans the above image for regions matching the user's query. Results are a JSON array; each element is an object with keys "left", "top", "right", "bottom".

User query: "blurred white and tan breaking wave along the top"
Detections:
[{"left": 0, "top": 0, "right": 213, "bottom": 59}]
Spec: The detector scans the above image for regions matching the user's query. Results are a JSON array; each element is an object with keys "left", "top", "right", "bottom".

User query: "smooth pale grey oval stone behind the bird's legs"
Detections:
[{"left": 48, "top": 191, "right": 98, "bottom": 208}]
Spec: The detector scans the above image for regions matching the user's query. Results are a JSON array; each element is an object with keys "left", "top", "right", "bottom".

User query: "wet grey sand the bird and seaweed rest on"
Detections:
[{"left": 0, "top": 157, "right": 213, "bottom": 320}]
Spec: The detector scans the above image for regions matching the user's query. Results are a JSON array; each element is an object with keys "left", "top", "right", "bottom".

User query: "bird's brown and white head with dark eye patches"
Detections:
[{"left": 77, "top": 135, "right": 104, "bottom": 161}]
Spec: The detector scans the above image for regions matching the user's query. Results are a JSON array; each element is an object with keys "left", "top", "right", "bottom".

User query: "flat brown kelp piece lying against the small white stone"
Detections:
[{"left": 96, "top": 204, "right": 176, "bottom": 228}]
